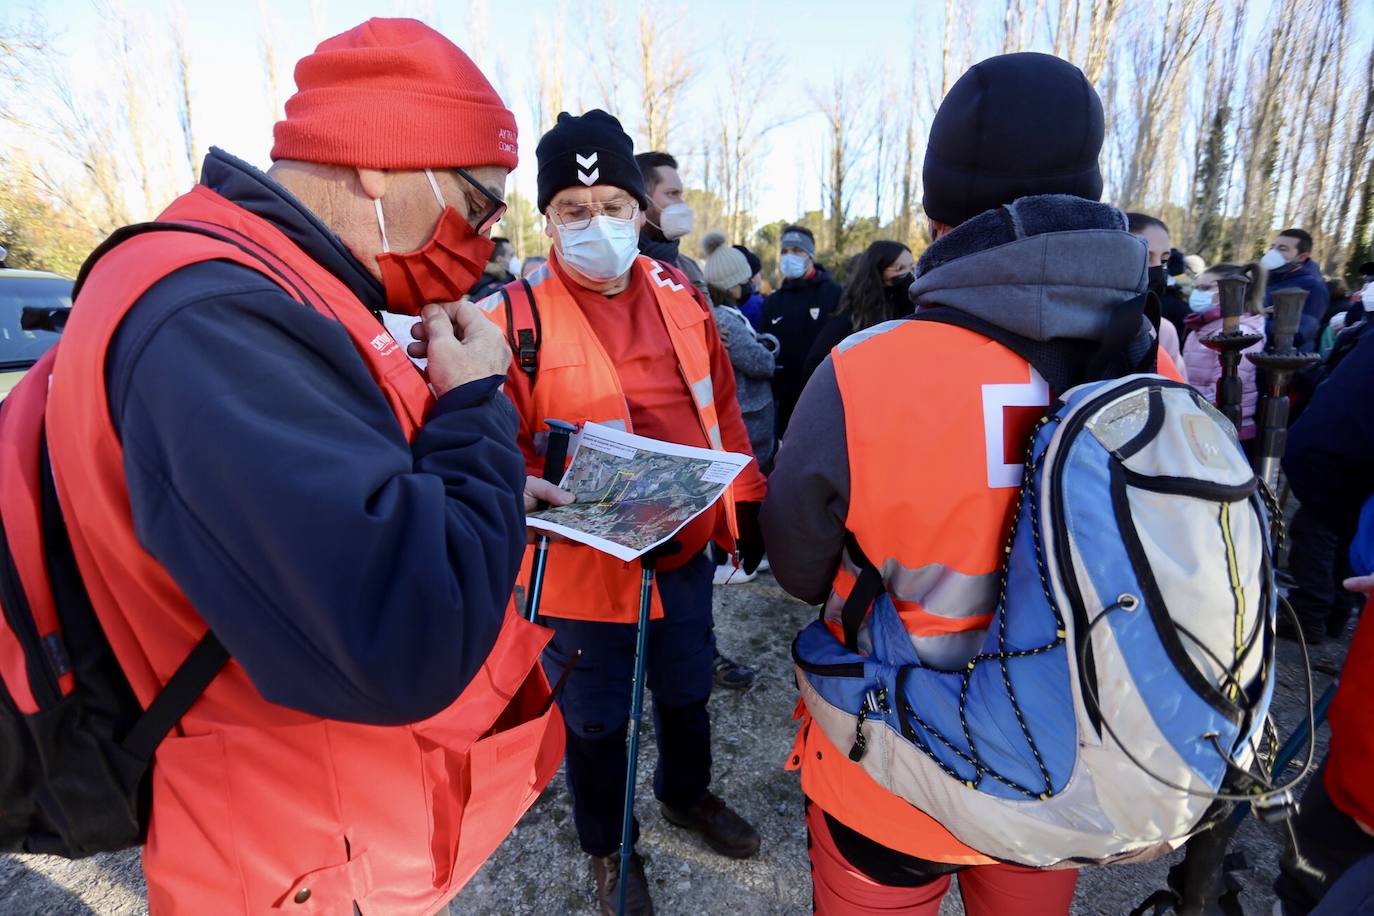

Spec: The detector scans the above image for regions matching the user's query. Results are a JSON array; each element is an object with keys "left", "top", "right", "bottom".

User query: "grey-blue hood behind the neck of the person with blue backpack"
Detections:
[{"left": 911, "top": 194, "right": 1149, "bottom": 341}]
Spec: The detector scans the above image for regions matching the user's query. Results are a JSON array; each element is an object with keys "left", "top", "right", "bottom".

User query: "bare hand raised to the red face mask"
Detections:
[{"left": 407, "top": 299, "right": 511, "bottom": 397}]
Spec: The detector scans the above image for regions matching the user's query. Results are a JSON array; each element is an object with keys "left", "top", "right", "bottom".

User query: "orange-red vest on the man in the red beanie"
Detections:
[{"left": 47, "top": 187, "right": 563, "bottom": 916}]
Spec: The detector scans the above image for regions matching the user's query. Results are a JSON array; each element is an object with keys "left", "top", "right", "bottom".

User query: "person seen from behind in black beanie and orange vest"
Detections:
[{"left": 763, "top": 54, "right": 1178, "bottom": 916}]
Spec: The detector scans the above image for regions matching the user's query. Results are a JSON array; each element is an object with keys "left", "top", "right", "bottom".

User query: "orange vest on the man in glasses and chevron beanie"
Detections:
[{"left": 478, "top": 255, "right": 763, "bottom": 623}]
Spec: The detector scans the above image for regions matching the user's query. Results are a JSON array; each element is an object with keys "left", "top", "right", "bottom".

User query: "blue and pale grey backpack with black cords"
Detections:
[{"left": 793, "top": 308, "right": 1276, "bottom": 867}]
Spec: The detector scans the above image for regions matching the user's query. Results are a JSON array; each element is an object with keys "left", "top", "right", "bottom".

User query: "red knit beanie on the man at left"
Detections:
[{"left": 272, "top": 19, "right": 517, "bottom": 169}]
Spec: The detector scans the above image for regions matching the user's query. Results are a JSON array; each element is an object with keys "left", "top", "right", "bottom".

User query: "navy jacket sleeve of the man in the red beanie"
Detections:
[{"left": 106, "top": 264, "right": 525, "bottom": 724}]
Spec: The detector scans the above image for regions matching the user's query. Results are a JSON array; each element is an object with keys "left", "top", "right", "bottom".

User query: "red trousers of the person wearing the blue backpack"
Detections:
[{"left": 807, "top": 805, "right": 1079, "bottom": 916}]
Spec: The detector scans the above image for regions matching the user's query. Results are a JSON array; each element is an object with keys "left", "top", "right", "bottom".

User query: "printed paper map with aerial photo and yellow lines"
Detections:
[{"left": 526, "top": 423, "right": 753, "bottom": 563}]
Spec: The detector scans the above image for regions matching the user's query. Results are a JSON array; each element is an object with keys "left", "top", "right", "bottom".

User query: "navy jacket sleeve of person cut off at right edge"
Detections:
[{"left": 1283, "top": 325, "right": 1374, "bottom": 538}]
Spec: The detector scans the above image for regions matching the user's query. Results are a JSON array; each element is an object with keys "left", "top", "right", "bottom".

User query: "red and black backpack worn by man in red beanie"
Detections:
[{"left": 0, "top": 222, "right": 287, "bottom": 858}]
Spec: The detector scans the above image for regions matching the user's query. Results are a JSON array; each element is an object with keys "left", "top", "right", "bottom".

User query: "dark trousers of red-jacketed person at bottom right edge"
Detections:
[{"left": 1274, "top": 762, "right": 1374, "bottom": 916}]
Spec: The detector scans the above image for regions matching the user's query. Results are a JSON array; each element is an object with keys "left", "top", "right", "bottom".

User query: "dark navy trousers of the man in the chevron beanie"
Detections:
[{"left": 544, "top": 553, "right": 716, "bottom": 856}]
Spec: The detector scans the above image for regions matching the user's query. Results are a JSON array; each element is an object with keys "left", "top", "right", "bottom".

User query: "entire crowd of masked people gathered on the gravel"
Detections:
[{"left": 10, "top": 19, "right": 1374, "bottom": 916}]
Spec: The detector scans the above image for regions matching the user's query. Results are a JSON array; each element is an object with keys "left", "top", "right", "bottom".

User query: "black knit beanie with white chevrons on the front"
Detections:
[{"left": 534, "top": 108, "right": 649, "bottom": 213}]
